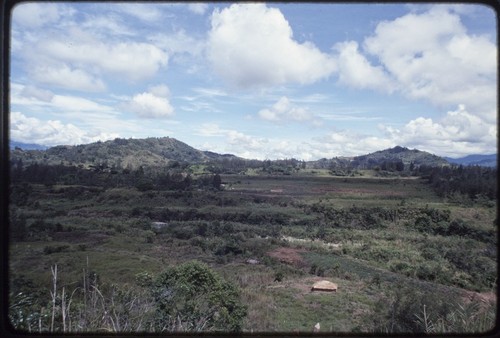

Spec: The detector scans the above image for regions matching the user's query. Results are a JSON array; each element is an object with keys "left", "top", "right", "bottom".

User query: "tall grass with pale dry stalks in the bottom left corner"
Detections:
[{"left": 9, "top": 265, "right": 154, "bottom": 333}]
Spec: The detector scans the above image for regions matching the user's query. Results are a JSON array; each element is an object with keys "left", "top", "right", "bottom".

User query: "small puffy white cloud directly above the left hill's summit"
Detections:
[{"left": 127, "top": 85, "right": 174, "bottom": 118}]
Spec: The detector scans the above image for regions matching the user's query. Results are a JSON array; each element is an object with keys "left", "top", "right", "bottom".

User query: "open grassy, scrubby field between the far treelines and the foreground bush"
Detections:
[{"left": 9, "top": 173, "right": 497, "bottom": 332}]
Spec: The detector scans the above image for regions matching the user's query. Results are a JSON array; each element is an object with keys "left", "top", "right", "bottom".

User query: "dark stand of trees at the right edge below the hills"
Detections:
[{"left": 416, "top": 165, "right": 497, "bottom": 200}]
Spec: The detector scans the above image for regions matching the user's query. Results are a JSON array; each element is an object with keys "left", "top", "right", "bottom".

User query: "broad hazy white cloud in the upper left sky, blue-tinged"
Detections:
[{"left": 13, "top": 23, "right": 169, "bottom": 92}]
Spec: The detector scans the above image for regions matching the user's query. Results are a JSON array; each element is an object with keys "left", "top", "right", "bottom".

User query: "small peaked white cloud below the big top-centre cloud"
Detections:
[{"left": 258, "top": 96, "right": 319, "bottom": 123}]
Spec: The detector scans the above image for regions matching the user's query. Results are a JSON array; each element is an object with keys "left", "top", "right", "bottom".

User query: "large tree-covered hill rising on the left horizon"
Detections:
[{"left": 11, "top": 137, "right": 241, "bottom": 169}]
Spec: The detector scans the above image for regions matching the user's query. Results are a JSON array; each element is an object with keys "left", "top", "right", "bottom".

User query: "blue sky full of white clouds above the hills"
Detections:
[{"left": 10, "top": 2, "right": 497, "bottom": 160}]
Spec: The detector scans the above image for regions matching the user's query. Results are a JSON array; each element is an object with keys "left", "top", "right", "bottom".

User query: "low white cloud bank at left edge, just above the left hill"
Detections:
[{"left": 10, "top": 112, "right": 119, "bottom": 146}]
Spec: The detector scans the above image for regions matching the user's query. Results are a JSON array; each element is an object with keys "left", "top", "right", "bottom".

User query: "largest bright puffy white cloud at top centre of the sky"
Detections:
[{"left": 207, "top": 4, "right": 336, "bottom": 88}]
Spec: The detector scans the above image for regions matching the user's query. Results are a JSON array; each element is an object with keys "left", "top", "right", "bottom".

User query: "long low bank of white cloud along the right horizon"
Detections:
[{"left": 200, "top": 105, "right": 497, "bottom": 160}]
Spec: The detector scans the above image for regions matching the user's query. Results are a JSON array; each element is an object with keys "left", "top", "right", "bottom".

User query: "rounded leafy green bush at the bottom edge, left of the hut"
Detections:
[{"left": 153, "top": 261, "right": 246, "bottom": 332}]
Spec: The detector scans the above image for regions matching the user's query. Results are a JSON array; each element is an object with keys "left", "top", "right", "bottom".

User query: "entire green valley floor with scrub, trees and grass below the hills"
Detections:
[{"left": 9, "top": 161, "right": 497, "bottom": 333}]
